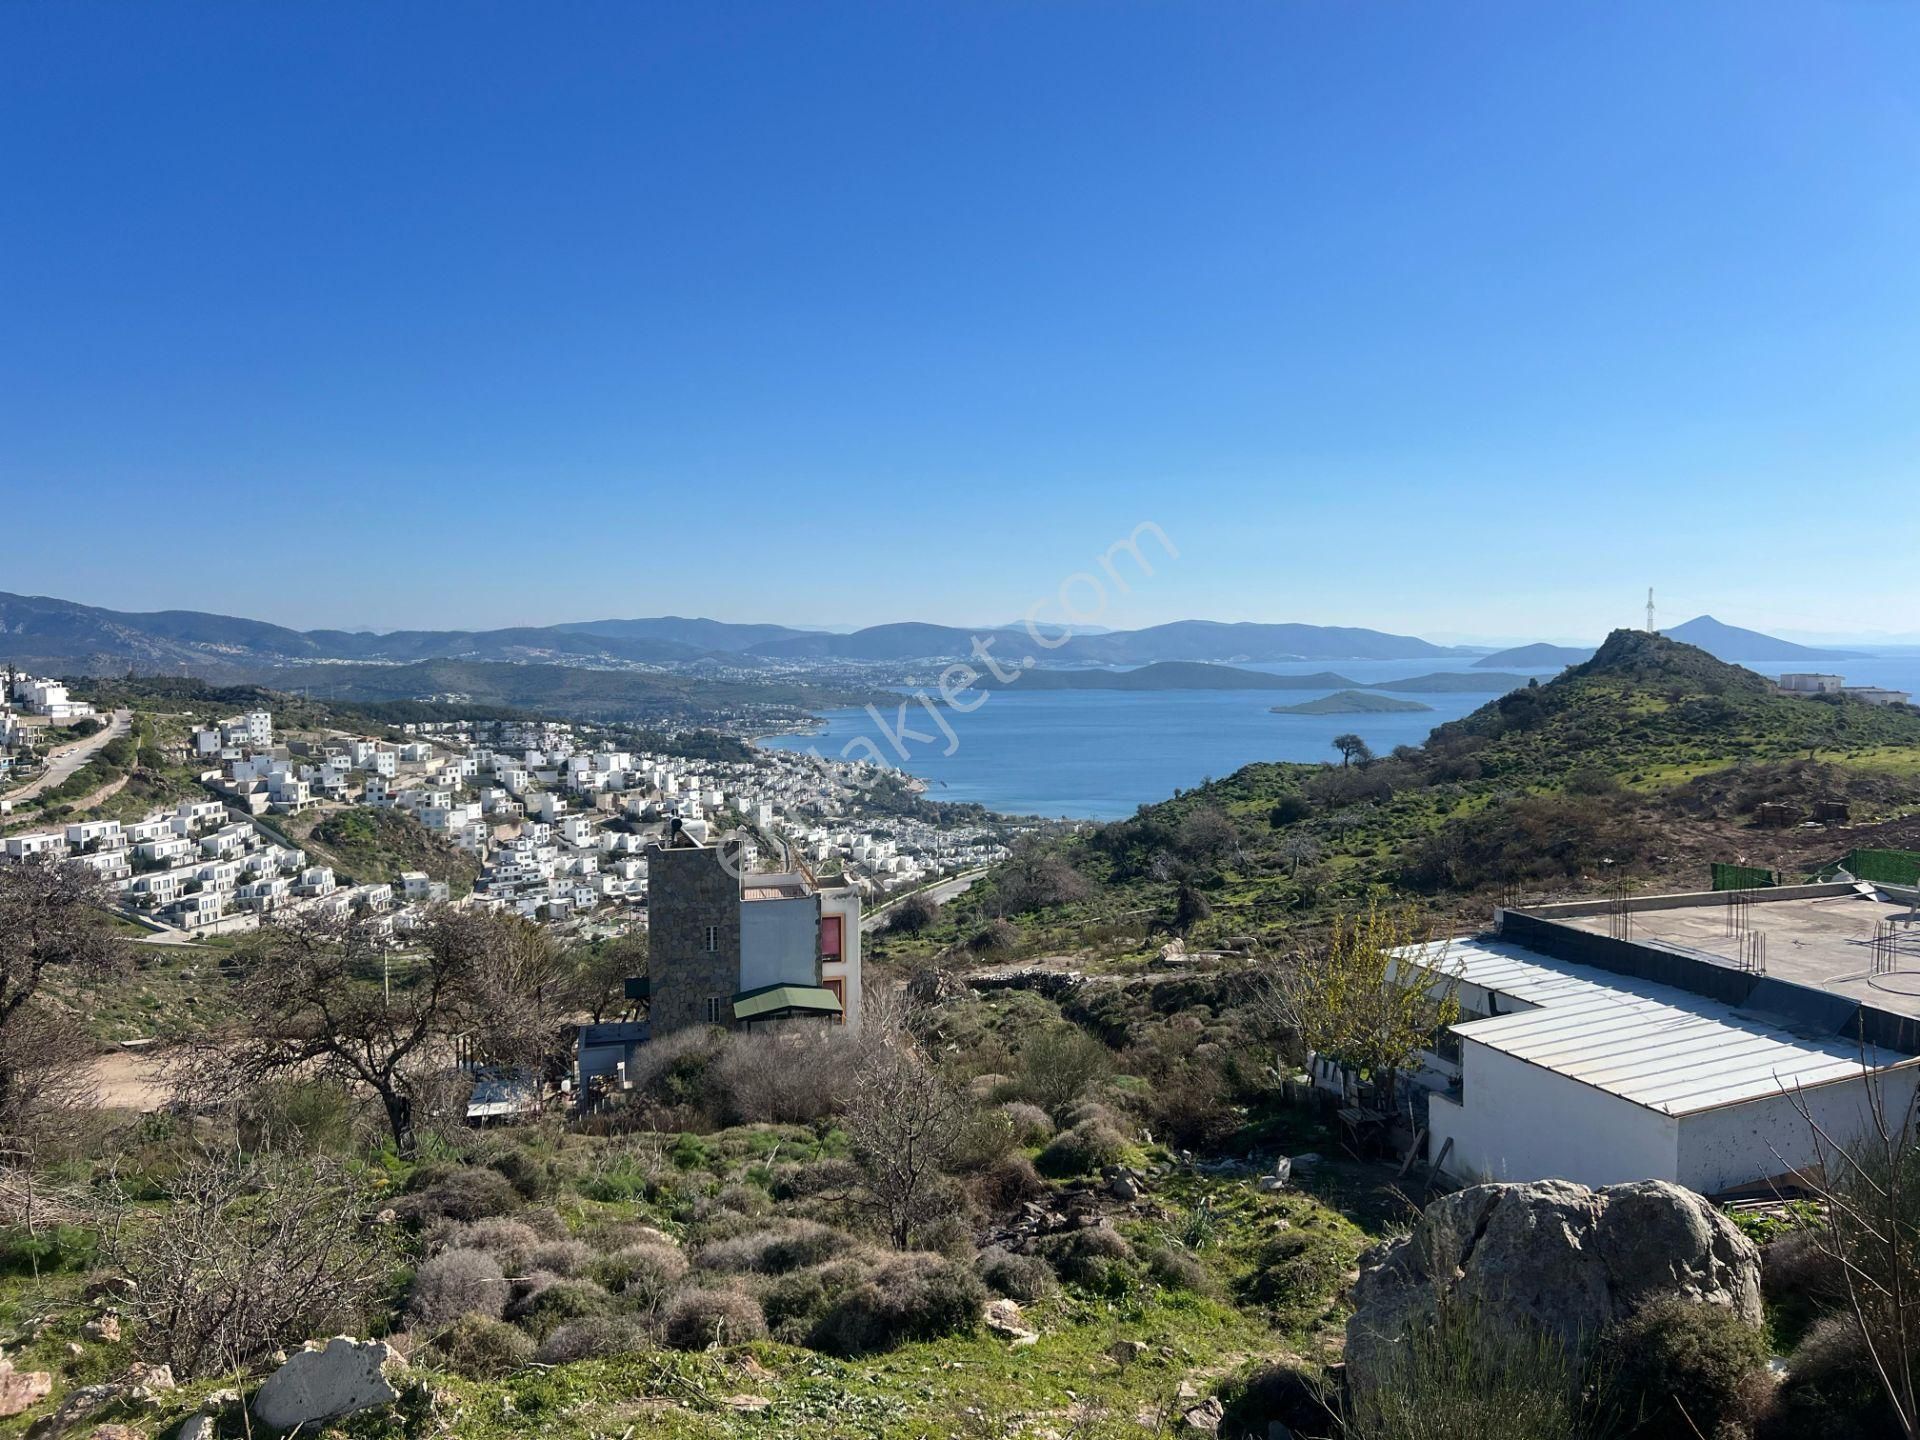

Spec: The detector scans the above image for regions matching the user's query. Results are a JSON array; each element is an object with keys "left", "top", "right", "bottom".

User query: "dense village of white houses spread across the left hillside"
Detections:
[{"left": 0, "top": 680, "right": 1006, "bottom": 933}]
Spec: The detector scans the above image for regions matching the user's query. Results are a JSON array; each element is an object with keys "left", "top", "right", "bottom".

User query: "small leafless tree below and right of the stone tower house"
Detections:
[{"left": 845, "top": 1014, "right": 970, "bottom": 1250}]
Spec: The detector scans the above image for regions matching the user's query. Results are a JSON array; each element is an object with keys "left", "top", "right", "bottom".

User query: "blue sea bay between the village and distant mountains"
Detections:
[{"left": 760, "top": 653, "right": 1920, "bottom": 820}]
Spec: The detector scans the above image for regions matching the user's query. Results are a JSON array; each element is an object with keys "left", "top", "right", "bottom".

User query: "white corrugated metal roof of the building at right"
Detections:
[{"left": 1404, "top": 941, "right": 1910, "bottom": 1116}]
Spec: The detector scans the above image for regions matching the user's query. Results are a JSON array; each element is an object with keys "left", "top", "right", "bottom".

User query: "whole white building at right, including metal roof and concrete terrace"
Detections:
[{"left": 1400, "top": 883, "right": 1920, "bottom": 1194}]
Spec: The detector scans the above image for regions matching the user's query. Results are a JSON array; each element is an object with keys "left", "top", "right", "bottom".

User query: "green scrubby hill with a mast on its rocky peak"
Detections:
[{"left": 906, "top": 632, "right": 1920, "bottom": 952}]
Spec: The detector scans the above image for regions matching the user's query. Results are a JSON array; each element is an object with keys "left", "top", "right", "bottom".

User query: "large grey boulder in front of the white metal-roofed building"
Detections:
[{"left": 1346, "top": 1181, "right": 1761, "bottom": 1390}]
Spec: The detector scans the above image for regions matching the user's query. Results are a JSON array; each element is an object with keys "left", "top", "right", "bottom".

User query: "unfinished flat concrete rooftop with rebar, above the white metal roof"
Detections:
[{"left": 1551, "top": 885, "right": 1920, "bottom": 1018}]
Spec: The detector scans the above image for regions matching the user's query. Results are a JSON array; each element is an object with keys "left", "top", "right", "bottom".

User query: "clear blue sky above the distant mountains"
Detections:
[{"left": 0, "top": 0, "right": 1920, "bottom": 637}]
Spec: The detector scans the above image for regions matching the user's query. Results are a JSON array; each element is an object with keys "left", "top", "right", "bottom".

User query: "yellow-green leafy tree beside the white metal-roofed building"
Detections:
[{"left": 1256, "top": 908, "right": 1459, "bottom": 1106}]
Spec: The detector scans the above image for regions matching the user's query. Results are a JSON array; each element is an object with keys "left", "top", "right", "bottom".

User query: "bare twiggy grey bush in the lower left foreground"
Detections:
[{"left": 119, "top": 1156, "right": 394, "bottom": 1379}]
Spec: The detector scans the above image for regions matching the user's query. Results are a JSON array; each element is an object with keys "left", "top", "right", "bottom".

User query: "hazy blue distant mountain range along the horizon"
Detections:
[{"left": 0, "top": 593, "right": 1853, "bottom": 689}]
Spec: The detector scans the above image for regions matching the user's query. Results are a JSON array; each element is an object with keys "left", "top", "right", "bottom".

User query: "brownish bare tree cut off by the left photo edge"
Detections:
[{"left": 0, "top": 858, "right": 123, "bottom": 1165}]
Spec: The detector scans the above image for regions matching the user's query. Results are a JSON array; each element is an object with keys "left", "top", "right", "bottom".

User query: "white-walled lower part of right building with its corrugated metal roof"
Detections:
[{"left": 1409, "top": 902, "right": 1920, "bottom": 1194}]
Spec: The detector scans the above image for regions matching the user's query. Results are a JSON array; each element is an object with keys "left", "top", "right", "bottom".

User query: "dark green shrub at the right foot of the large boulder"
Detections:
[{"left": 1594, "top": 1300, "right": 1766, "bottom": 1440}]
